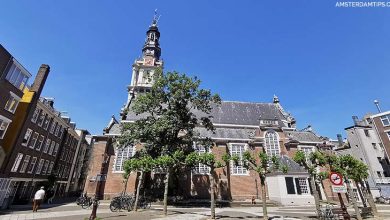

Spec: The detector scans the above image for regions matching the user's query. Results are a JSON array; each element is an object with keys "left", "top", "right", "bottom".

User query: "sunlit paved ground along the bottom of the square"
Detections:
[{"left": 0, "top": 201, "right": 390, "bottom": 220}]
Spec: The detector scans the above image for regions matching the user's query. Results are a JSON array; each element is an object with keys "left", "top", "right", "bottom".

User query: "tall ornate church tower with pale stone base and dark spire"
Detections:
[{"left": 121, "top": 11, "right": 163, "bottom": 117}]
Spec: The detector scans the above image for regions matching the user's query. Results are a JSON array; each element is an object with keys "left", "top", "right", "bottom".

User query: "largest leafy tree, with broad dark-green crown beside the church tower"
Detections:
[{"left": 119, "top": 70, "right": 221, "bottom": 215}]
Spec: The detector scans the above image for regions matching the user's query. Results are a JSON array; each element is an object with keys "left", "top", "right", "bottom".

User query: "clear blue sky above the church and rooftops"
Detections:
[{"left": 0, "top": 0, "right": 390, "bottom": 138}]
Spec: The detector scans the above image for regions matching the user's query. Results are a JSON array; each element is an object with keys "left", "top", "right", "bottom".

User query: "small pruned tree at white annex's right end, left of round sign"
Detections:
[{"left": 293, "top": 150, "right": 328, "bottom": 218}]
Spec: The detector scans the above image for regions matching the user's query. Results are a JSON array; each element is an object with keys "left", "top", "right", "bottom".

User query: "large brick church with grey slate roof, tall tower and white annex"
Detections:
[{"left": 85, "top": 17, "right": 338, "bottom": 205}]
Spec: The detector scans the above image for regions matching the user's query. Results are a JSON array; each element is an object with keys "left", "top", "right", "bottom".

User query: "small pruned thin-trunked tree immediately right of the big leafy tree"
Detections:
[{"left": 185, "top": 139, "right": 230, "bottom": 219}]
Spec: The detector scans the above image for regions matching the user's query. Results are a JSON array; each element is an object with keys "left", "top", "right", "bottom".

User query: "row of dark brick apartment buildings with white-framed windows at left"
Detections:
[{"left": 0, "top": 44, "right": 89, "bottom": 208}]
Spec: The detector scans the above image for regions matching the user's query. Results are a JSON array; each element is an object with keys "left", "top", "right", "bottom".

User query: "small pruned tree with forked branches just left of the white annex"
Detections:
[{"left": 239, "top": 151, "right": 288, "bottom": 220}]
